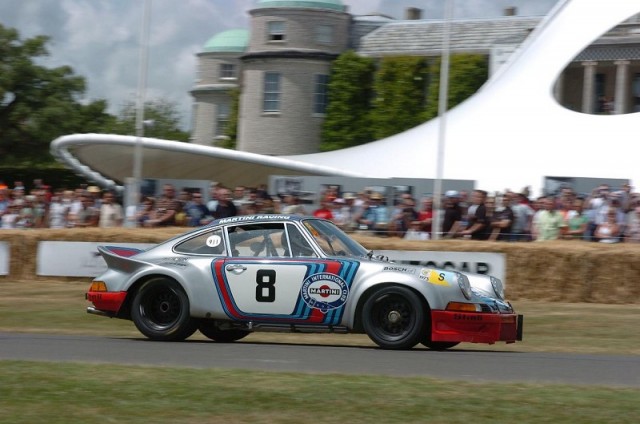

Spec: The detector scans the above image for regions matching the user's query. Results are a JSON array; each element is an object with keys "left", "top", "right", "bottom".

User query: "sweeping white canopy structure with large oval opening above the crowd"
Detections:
[{"left": 51, "top": 0, "right": 640, "bottom": 192}]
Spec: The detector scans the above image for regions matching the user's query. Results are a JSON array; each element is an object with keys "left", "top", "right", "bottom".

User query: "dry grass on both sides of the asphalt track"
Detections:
[{"left": 0, "top": 281, "right": 640, "bottom": 424}]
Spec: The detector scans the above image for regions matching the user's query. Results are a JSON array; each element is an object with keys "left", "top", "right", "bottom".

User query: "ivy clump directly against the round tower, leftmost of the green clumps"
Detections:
[{"left": 320, "top": 51, "right": 374, "bottom": 151}]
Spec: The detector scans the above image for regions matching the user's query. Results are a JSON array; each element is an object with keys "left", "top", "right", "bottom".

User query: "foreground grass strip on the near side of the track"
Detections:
[{"left": 0, "top": 361, "right": 640, "bottom": 424}]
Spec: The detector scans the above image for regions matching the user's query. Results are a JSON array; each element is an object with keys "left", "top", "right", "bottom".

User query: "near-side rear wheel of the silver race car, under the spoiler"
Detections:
[{"left": 131, "top": 278, "right": 198, "bottom": 341}]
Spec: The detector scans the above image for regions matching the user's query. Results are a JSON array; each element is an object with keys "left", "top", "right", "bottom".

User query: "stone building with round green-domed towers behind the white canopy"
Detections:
[{"left": 191, "top": 0, "right": 640, "bottom": 155}]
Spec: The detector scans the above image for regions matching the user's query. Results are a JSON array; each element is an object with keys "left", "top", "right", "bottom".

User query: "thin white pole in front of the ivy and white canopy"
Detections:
[{"left": 431, "top": 0, "right": 453, "bottom": 240}]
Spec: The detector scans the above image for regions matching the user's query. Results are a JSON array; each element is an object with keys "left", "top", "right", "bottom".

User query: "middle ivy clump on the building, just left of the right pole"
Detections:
[{"left": 364, "top": 56, "right": 428, "bottom": 139}]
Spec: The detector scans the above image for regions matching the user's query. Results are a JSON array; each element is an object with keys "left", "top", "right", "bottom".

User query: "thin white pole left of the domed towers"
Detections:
[{"left": 127, "top": 0, "right": 151, "bottom": 227}]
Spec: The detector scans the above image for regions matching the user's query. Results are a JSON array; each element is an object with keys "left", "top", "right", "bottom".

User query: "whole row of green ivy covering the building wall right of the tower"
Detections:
[{"left": 321, "top": 52, "right": 488, "bottom": 146}]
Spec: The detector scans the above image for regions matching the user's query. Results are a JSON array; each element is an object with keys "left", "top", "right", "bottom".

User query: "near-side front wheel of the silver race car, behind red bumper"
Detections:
[{"left": 362, "top": 286, "right": 425, "bottom": 349}]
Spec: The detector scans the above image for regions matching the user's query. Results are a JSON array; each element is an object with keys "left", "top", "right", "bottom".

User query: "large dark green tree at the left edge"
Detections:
[{"left": 0, "top": 25, "right": 110, "bottom": 165}]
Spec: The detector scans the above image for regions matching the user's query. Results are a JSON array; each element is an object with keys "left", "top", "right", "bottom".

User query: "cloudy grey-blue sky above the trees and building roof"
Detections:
[{"left": 0, "top": 0, "right": 558, "bottom": 130}]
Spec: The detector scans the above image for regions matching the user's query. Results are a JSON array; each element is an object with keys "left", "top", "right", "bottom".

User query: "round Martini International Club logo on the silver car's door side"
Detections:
[{"left": 300, "top": 272, "right": 349, "bottom": 313}]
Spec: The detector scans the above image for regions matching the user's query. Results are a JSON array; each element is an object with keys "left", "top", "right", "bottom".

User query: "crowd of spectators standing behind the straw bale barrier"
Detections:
[{"left": 0, "top": 180, "right": 640, "bottom": 243}]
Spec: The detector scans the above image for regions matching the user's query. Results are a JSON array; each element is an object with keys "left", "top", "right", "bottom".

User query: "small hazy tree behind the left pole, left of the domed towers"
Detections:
[{"left": 109, "top": 99, "right": 189, "bottom": 141}]
